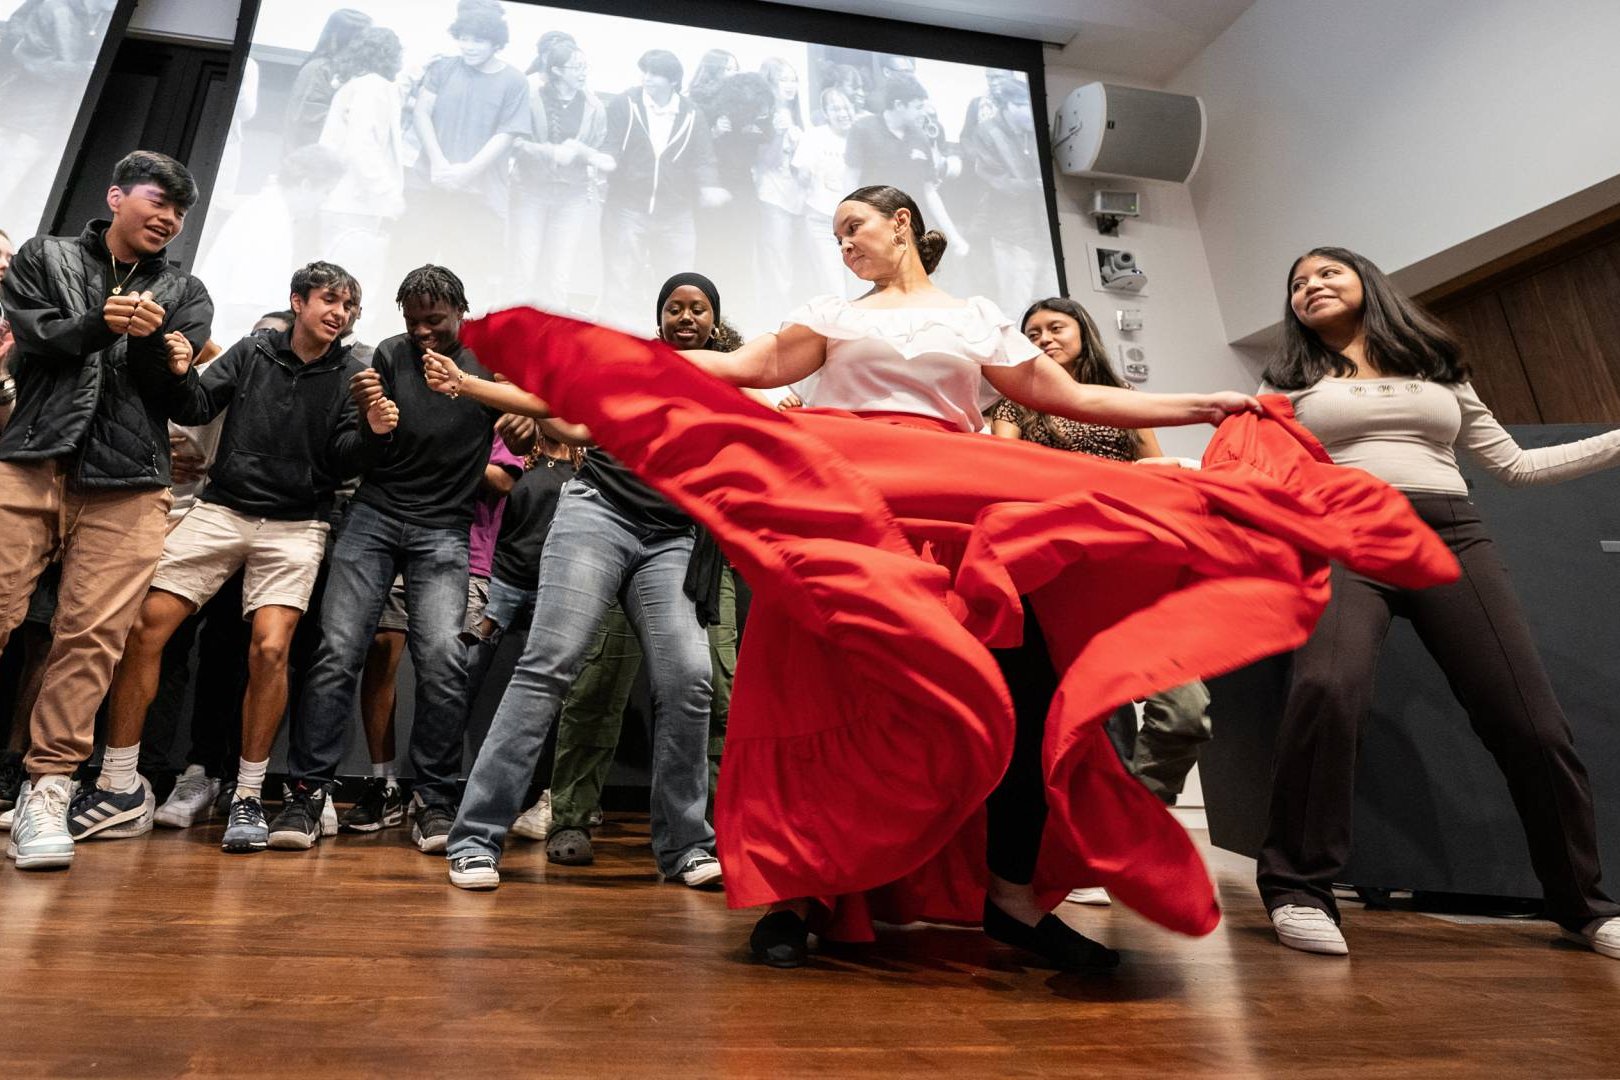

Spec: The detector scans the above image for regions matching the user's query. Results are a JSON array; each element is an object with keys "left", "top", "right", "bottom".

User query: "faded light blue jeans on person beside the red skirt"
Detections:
[{"left": 446, "top": 481, "right": 714, "bottom": 876}]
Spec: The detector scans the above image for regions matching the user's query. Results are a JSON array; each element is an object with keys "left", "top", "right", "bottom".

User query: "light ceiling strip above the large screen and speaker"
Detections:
[{"left": 771, "top": 0, "right": 1254, "bottom": 83}]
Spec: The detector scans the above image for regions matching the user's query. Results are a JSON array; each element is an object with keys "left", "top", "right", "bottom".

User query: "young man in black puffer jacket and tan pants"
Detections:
[{"left": 0, "top": 151, "right": 212, "bottom": 870}]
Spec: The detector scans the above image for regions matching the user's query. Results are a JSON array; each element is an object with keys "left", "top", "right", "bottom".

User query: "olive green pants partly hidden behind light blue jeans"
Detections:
[{"left": 551, "top": 567, "right": 737, "bottom": 831}]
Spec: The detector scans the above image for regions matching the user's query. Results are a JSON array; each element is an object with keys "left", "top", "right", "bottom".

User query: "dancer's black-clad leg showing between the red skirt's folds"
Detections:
[{"left": 985, "top": 599, "right": 1058, "bottom": 886}]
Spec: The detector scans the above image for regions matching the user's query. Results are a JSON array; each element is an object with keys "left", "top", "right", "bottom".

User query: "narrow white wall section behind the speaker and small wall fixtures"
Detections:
[{"left": 1047, "top": 66, "right": 1259, "bottom": 457}]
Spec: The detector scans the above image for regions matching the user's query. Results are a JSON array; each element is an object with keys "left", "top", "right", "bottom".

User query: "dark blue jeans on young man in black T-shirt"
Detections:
[{"left": 287, "top": 502, "right": 467, "bottom": 806}]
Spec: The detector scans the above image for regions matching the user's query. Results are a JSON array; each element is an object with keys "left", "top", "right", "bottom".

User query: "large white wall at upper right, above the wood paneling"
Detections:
[{"left": 1166, "top": 0, "right": 1620, "bottom": 340}]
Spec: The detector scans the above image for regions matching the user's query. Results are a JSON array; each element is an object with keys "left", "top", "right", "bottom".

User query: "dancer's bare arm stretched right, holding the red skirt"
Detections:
[{"left": 983, "top": 356, "right": 1260, "bottom": 427}]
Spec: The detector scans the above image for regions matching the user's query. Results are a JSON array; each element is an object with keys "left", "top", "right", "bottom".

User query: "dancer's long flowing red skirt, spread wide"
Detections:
[{"left": 462, "top": 308, "right": 1458, "bottom": 939}]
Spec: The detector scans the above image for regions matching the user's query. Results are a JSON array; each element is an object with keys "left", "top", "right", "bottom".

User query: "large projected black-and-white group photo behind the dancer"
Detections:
[{"left": 196, "top": 0, "right": 1058, "bottom": 340}]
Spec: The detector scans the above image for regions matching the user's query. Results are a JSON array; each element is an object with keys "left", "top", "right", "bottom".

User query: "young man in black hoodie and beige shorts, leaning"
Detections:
[{"left": 84, "top": 262, "right": 388, "bottom": 852}]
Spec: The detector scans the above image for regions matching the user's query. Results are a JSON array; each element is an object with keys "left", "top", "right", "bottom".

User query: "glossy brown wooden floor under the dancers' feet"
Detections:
[{"left": 0, "top": 819, "right": 1620, "bottom": 1080}]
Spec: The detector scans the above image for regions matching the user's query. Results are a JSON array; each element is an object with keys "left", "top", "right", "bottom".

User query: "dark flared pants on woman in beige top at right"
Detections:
[{"left": 1259, "top": 494, "right": 1620, "bottom": 929}]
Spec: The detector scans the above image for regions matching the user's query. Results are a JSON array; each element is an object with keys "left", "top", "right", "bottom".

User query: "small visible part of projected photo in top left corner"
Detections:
[{"left": 0, "top": 0, "right": 118, "bottom": 243}]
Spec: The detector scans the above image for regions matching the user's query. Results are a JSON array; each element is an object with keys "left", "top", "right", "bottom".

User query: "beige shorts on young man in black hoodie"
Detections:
[{"left": 152, "top": 502, "right": 329, "bottom": 617}]
